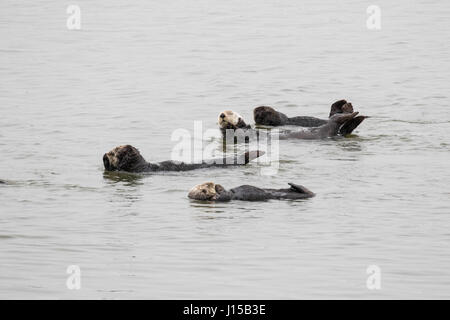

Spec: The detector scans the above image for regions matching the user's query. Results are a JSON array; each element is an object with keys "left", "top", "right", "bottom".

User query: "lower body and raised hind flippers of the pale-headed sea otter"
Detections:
[{"left": 279, "top": 112, "right": 365, "bottom": 139}]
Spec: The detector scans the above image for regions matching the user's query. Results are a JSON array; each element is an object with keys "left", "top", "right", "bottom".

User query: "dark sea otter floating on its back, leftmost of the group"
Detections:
[{"left": 103, "top": 145, "right": 264, "bottom": 173}]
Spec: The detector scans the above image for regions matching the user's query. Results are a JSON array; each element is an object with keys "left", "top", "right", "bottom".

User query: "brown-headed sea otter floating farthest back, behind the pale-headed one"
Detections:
[{"left": 253, "top": 100, "right": 366, "bottom": 135}]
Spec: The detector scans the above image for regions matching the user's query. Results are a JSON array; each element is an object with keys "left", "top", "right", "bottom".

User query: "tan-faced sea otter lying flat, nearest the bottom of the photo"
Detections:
[{"left": 188, "top": 182, "right": 315, "bottom": 201}]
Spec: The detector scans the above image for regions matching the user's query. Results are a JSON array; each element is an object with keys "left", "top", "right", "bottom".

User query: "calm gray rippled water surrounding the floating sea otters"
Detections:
[{"left": 0, "top": 0, "right": 450, "bottom": 299}]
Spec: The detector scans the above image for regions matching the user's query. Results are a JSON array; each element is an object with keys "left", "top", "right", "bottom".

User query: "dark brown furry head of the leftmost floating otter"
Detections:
[{"left": 103, "top": 145, "right": 145, "bottom": 171}]
